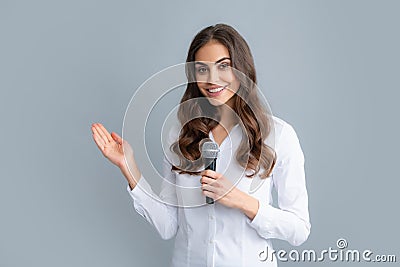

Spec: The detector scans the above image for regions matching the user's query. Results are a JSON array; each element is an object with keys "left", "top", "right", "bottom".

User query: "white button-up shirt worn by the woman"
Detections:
[{"left": 127, "top": 116, "right": 311, "bottom": 267}]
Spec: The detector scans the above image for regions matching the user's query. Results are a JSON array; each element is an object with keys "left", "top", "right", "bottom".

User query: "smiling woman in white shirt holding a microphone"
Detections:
[{"left": 92, "top": 24, "right": 310, "bottom": 266}]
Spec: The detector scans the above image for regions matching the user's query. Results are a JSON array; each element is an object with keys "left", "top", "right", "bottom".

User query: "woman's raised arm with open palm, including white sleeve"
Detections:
[{"left": 91, "top": 123, "right": 178, "bottom": 239}]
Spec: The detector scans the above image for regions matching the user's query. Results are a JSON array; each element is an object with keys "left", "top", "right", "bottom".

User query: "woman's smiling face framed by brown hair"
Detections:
[{"left": 195, "top": 41, "right": 240, "bottom": 107}]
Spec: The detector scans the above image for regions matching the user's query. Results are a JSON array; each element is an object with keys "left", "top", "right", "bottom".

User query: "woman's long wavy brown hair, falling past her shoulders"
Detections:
[{"left": 170, "top": 24, "right": 276, "bottom": 178}]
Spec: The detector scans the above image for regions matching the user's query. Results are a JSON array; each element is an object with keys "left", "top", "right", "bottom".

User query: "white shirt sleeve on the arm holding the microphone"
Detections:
[{"left": 247, "top": 124, "right": 311, "bottom": 246}]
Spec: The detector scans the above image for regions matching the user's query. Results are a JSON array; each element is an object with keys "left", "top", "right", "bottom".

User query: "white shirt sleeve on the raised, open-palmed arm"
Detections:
[{"left": 127, "top": 157, "right": 178, "bottom": 239}]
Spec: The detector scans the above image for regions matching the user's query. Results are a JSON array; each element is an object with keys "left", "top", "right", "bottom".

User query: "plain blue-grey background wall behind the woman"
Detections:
[{"left": 0, "top": 0, "right": 400, "bottom": 267}]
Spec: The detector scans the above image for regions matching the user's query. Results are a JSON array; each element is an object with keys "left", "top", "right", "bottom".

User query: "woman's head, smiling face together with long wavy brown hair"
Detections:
[{"left": 172, "top": 24, "right": 276, "bottom": 178}]
